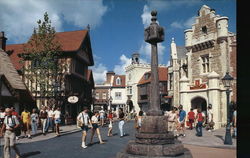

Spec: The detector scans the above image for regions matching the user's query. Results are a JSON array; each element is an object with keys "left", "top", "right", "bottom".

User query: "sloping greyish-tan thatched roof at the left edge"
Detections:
[{"left": 0, "top": 51, "right": 26, "bottom": 90}]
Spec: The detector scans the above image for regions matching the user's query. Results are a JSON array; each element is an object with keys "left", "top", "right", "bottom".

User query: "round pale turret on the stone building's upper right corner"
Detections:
[{"left": 216, "top": 16, "right": 228, "bottom": 38}]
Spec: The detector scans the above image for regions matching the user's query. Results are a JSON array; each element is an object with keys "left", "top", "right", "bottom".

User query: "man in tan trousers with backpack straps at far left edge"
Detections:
[{"left": 0, "top": 108, "right": 21, "bottom": 158}]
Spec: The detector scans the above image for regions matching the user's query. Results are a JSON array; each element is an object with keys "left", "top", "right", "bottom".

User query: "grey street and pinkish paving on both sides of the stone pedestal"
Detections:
[{"left": 0, "top": 121, "right": 236, "bottom": 158}]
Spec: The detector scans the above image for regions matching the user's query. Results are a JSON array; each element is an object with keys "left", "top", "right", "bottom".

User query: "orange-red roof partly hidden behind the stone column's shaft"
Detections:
[{"left": 138, "top": 67, "right": 168, "bottom": 85}]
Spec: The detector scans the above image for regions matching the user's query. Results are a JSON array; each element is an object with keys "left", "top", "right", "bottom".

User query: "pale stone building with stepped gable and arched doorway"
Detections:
[{"left": 169, "top": 5, "right": 237, "bottom": 128}]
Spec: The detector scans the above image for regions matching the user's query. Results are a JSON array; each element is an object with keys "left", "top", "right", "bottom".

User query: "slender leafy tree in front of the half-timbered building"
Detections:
[{"left": 21, "top": 12, "right": 61, "bottom": 106}]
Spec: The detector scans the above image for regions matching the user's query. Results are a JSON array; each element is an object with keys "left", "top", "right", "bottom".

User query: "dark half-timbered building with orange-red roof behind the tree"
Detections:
[{"left": 6, "top": 30, "right": 94, "bottom": 118}]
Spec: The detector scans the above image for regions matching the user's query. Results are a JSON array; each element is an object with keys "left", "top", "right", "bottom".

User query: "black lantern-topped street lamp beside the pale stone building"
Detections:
[{"left": 221, "top": 72, "right": 234, "bottom": 145}]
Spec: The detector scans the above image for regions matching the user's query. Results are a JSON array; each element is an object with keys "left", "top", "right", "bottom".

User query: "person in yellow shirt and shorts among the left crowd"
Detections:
[{"left": 21, "top": 108, "right": 31, "bottom": 139}]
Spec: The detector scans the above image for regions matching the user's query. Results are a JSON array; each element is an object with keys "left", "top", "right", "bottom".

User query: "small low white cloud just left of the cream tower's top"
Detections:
[{"left": 114, "top": 54, "right": 131, "bottom": 75}]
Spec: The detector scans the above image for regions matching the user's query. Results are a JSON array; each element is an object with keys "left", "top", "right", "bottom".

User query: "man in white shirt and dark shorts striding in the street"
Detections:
[{"left": 77, "top": 107, "right": 92, "bottom": 149}]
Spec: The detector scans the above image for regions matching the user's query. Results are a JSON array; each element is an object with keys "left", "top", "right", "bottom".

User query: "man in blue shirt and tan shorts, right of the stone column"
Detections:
[{"left": 177, "top": 105, "right": 186, "bottom": 137}]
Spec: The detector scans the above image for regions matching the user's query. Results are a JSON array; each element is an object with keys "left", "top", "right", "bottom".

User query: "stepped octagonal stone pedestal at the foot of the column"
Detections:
[{"left": 117, "top": 116, "right": 192, "bottom": 158}]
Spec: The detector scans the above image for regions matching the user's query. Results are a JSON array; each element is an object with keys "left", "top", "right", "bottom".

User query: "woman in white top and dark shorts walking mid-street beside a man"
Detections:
[{"left": 90, "top": 112, "right": 104, "bottom": 144}]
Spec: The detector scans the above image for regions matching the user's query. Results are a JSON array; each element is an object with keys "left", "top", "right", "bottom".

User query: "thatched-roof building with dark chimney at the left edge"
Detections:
[{"left": 0, "top": 32, "right": 35, "bottom": 114}]
